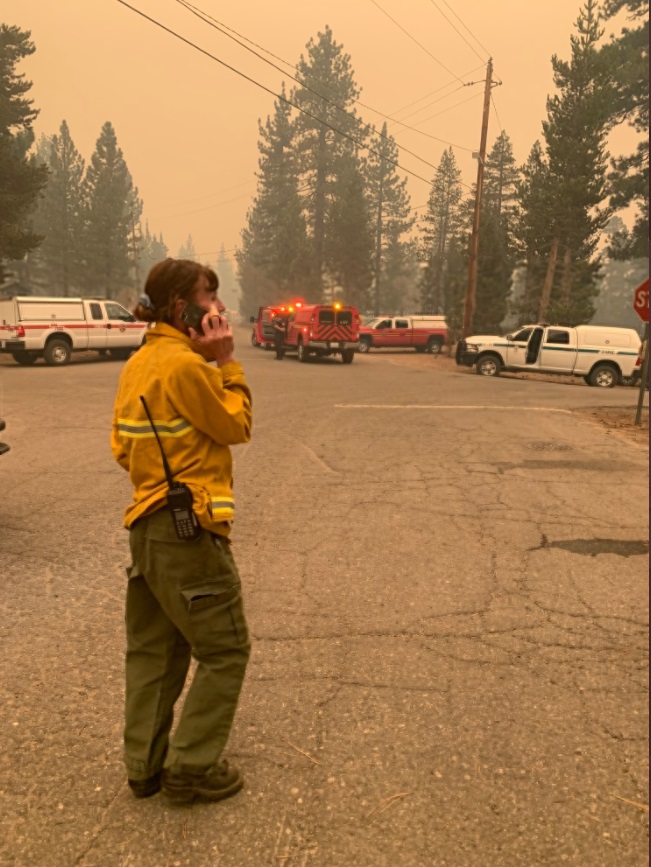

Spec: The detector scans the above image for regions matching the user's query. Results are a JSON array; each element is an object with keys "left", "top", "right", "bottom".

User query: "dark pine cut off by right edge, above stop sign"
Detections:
[{"left": 600, "top": 0, "right": 649, "bottom": 259}]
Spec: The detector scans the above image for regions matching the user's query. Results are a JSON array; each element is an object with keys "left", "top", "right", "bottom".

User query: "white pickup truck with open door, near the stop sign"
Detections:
[{"left": 457, "top": 325, "right": 642, "bottom": 388}]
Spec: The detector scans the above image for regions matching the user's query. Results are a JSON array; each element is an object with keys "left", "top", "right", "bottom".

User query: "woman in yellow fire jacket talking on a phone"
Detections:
[{"left": 111, "top": 259, "right": 251, "bottom": 804}]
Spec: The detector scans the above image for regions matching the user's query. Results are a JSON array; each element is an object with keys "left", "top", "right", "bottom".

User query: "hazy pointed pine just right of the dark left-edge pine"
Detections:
[{"left": 34, "top": 120, "right": 84, "bottom": 295}]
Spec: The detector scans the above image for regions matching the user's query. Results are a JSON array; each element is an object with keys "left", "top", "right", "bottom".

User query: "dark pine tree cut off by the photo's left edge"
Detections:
[{"left": 0, "top": 24, "right": 48, "bottom": 284}]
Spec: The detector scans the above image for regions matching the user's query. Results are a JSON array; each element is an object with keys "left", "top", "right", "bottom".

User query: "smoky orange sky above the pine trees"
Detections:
[{"left": 2, "top": 0, "right": 636, "bottom": 272}]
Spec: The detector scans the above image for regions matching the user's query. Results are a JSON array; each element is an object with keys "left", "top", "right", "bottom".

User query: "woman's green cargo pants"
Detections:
[{"left": 124, "top": 509, "right": 250, "bottom": 780}]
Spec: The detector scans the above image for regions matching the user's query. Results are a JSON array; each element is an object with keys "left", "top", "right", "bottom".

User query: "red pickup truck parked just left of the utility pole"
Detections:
[{"left": 359, "top": 316, "right": 448, "bottom": 355}]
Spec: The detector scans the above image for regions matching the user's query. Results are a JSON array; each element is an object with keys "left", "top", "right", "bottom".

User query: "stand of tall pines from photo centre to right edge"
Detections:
[{"left": 236, "top": 0, "right": 649, "bottom": 332}]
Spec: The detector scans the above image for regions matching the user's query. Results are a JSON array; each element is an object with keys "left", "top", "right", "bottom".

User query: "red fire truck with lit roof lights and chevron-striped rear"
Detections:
[{"left": 285, "top": 301, "right": 361, "bottom": 364}]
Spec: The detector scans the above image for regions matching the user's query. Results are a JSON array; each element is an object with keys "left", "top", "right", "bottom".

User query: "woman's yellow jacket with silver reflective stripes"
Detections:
[{"left": 111, "top": 323, "right": 251, "bottom": 534}]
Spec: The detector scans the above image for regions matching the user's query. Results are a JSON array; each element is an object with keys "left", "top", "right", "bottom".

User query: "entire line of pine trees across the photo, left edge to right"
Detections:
[{"left": 0, "top": 0, "right": 649, "bottom": 331}]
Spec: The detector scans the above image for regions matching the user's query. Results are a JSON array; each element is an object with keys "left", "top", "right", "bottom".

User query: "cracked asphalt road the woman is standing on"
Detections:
[{"left": 0, "top": 332, "right": 649, "bottom": 867}]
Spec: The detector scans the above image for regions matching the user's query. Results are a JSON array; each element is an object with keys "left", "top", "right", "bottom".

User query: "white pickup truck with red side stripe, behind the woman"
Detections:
[{"left": 0, "top": 295, "right": 147, "bottom": 365}]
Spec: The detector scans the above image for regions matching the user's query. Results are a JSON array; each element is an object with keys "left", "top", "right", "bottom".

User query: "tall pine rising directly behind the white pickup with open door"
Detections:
[{"left": 539, "top": 0, "right": 610, "bottom": 325}]
